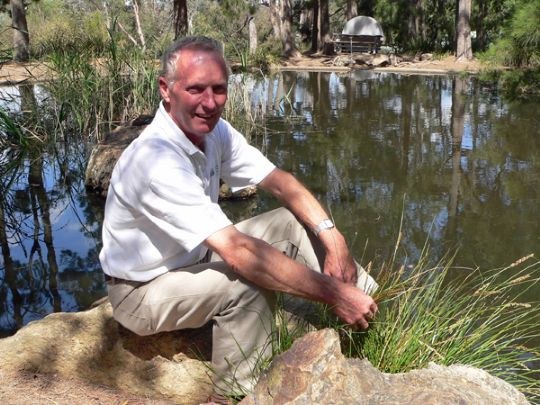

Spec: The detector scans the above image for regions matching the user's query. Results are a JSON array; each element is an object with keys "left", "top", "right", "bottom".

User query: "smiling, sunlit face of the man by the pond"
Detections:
[{"left": 159, "top": 49, "right": 227, "bottom": 146}]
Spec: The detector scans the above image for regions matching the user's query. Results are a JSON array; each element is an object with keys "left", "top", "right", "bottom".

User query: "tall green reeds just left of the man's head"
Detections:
[{"left": 46, "top": 38, "right": 159, "bottom": 137}]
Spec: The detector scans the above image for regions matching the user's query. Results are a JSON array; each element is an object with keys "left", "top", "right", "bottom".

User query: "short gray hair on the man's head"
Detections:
[{"left": 159, "top": 35, "right": 229, "bottom": 80}]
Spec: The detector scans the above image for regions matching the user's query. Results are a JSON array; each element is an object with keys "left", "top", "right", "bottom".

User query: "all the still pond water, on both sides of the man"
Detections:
[{"left": 0, "top": 71, "right": 540, "bottom": 336}]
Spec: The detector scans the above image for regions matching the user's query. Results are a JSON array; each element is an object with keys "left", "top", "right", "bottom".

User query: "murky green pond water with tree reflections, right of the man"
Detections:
[{"left": 247, "top": 71, "right": 540, "bottom": 276}]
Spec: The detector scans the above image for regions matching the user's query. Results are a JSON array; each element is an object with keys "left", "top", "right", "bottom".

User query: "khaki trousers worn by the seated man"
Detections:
[{"left": 108, "top": 208, "right": 377, "bottom": 394}]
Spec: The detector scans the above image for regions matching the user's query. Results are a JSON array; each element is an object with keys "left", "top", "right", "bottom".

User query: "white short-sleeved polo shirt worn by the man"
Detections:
[{"left": 99, "top": 104, "right": 275, "bottom": 281}]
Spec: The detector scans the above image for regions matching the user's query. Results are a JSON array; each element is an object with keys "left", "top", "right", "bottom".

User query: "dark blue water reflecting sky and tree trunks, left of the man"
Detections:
[{"left": 0, "top": 144, "right": 104, "bottom": 335}]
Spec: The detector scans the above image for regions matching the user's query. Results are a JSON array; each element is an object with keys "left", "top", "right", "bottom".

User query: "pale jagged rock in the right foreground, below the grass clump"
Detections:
[{"left": 241, "top": 329, "right": 528, "bottom": 405}]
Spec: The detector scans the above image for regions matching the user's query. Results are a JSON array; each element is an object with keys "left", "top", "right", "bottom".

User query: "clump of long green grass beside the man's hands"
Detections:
[{"left": 318, "top": 249, "right": 540, "bottom": 401}]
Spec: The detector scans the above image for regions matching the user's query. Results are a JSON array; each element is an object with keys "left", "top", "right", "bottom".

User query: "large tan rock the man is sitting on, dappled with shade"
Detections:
[{"left": 0, "top": 303, "right": 212, "bottom": 404}]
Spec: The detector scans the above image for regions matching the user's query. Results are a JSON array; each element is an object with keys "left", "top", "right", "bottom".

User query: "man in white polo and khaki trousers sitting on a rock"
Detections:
[{"left": 100, "top": 37, "right": 377, "bottom": 400}]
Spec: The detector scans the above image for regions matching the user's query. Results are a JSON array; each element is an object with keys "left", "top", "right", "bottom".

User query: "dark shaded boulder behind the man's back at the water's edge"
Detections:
[{"left": 85, "top": 116, "right": 257, "bottom": 200}]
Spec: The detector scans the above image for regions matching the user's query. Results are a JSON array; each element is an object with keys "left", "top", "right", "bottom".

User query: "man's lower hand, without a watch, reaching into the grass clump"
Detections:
[{"left": 333, "top": 284, "right": 378, "bottom": 329}]
